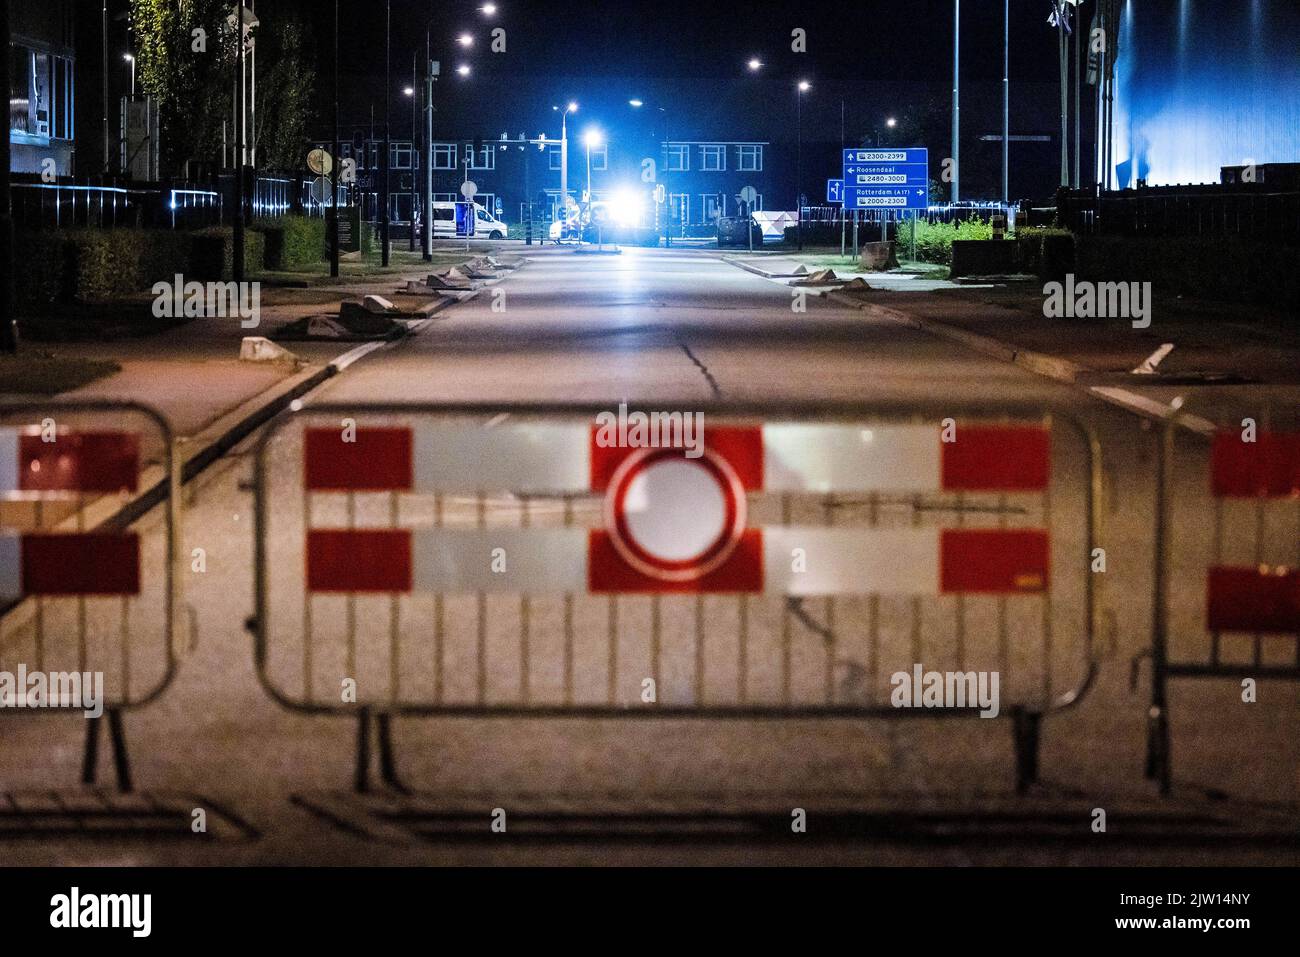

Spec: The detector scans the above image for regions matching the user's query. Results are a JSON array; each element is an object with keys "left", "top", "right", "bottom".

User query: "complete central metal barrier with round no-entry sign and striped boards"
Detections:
[{"left": 250, "top": 404, "right": 1100, "bottom": 789}]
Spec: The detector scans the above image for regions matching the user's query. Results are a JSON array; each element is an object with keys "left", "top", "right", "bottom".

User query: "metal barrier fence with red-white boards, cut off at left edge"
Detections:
[{"left": 0, "top": 400, "right": 179, "bottom": 791}]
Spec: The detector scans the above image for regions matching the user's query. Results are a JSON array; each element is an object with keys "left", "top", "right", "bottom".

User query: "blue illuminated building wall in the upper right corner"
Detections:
[{"left": 1114, "top": 0, "right": 1300, "bottom": 189}]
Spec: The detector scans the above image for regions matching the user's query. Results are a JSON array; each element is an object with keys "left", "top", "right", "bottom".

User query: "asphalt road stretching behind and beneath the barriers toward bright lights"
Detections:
[{"left": 0, "top": 248, "right": 1300, "bottom": 863}]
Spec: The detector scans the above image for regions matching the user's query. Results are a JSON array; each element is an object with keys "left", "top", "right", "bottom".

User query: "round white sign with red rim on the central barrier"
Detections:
[{"left": 605, "top": 449, "right": 746, "bottom": 581}]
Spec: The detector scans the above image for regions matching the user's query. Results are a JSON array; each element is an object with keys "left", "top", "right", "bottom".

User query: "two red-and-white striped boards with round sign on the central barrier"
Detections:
[{"left": 304, "top": 423, "right": 1050, "bottom": 596}]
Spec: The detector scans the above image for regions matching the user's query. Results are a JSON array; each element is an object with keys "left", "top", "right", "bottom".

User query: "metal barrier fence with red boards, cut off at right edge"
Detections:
[{"left": 1147, "top": 394, "right": 1300, "bottom": 793}]
